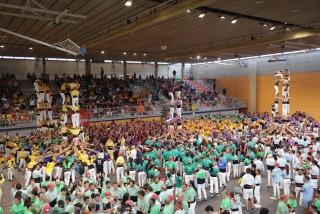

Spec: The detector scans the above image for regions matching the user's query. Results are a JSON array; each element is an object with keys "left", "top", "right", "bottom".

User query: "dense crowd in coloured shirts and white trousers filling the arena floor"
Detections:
[{"left": 0, "top": 109, "right": 320, "bottom": 214}]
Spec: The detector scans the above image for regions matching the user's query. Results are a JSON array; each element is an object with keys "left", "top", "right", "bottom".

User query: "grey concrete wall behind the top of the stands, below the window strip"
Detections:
[{"left": 0, "top": 59, "right": 191, "bottom": 80}]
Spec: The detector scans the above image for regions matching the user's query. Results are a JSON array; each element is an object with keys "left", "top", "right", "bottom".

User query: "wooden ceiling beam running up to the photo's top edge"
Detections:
[{"left": 85, "top": 0, "right": 217, "bottom": 48}]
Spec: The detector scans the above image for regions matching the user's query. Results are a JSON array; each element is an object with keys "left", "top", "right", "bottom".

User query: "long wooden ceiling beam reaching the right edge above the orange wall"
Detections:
[{"left": 165, "top": 29, "right": 320, "bottom": 60}]
